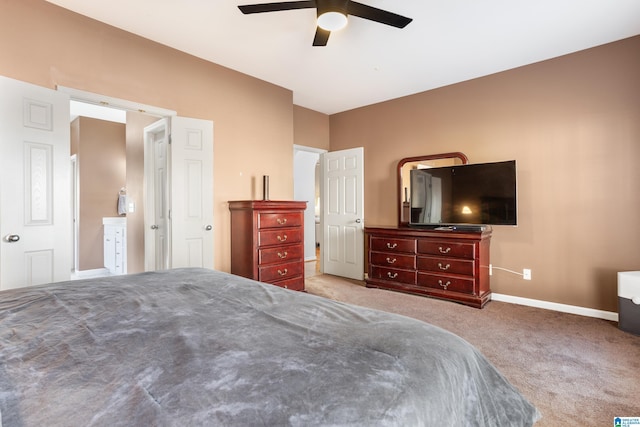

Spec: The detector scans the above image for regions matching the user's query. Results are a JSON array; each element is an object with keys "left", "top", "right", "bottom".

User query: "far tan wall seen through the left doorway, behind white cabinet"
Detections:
[{"left": 71, "top": 117, "right": 127, "bottom": 270}]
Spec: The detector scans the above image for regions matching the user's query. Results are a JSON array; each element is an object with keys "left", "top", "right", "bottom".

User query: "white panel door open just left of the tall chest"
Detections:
[{"left": 171, "top": 117, "right": 213, "bottom": 268}]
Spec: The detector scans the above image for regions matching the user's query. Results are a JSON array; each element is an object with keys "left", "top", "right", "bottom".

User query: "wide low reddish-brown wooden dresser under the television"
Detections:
[{"left": 365, "top": 227, "right": 491, "bottom": 308}]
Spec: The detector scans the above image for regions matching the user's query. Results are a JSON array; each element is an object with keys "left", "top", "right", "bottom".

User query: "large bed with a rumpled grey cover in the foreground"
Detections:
[{"left": 0, "top": 269, "right": 540, "bottom": 427}]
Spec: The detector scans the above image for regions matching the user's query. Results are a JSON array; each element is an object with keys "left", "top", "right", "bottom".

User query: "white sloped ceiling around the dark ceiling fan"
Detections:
[{"left": 47, "top": 0, "right": 640, "bottom": 114}]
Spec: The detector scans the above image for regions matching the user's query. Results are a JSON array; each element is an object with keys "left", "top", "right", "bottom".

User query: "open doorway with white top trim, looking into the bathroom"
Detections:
[{"left": 66, "top": 94, "right": 175, "bottom": 278}]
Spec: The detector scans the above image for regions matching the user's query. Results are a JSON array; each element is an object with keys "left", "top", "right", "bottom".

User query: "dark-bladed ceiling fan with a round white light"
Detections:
[{"left": 238, "top": 0, "right": 412, "bottom": 46}]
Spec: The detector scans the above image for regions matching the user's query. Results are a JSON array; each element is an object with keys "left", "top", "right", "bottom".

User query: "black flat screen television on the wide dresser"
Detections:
[{"left": 409, "top": 160, "right": 518, "bottom": 228}]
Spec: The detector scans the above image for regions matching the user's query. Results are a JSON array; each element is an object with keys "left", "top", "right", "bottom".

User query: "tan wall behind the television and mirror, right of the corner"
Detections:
[{"left": 330, "top": 37, "right": 640, "bottom": 311}]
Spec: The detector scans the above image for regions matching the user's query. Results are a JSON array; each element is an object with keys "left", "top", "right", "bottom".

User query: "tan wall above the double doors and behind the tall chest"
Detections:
[{"left": 0, "top": 0, "right": 293, "bottom": 271}]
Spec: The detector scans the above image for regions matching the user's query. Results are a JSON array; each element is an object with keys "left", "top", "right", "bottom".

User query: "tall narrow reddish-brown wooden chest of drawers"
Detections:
[{"left": 229, "top": 200, "right": 307, "bottom": 291}]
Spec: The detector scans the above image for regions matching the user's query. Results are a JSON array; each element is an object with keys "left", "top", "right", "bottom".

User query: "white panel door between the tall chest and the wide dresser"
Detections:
[{"left": 320, "top": 147, "right": 364, "bottom": 280}]
